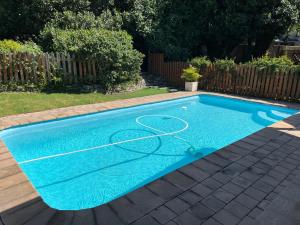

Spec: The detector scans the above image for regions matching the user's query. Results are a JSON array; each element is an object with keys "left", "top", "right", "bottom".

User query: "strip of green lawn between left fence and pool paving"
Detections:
[{"left": 0, "top": 88, "right": 168, "bottom": 117}]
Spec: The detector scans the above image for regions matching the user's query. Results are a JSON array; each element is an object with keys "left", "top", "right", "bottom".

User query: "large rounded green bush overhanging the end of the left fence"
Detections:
[{"left": 47, "top": 29, "right": 143, "bottom": 90}]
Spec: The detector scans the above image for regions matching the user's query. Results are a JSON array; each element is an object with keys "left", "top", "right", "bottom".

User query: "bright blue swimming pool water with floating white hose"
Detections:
[{"left": 0, "top": 95, "right": 296, "bottom": 210}]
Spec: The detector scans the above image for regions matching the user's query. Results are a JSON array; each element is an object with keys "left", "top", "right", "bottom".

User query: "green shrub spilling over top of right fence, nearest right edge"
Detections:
[{"left": 248, "top": 55, "right": 294, "bottom": 71}]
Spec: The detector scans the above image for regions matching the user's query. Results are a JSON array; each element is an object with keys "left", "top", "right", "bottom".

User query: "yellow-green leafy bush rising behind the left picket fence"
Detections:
[{"left": 0, "top": 40, "right": 42, "bottom": 54}]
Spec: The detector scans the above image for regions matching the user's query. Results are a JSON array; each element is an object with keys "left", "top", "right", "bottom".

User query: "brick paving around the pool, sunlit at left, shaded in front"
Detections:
[{"left": 0, "top": 92, "right": 300, "bottom": 225}]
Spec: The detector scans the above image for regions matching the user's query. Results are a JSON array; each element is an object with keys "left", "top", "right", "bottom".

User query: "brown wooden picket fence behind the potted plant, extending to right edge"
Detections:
[{"left": 148, "top": 54, "right": 300, "bottom": 102}]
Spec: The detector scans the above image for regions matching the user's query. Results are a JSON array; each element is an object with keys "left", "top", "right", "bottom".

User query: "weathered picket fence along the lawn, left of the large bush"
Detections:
[{"left": 0, "top": 53, "right": 97, "bottom": 84}]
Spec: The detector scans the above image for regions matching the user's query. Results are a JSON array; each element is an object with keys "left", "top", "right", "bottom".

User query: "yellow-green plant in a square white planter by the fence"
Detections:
[{"left": 181, "top": 66, "right": 201, "bottom": 91}]
